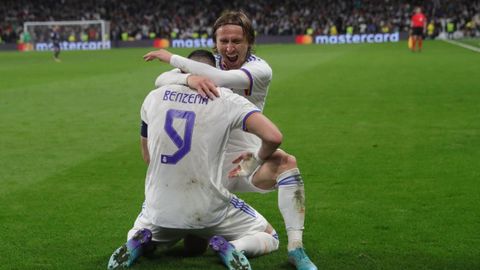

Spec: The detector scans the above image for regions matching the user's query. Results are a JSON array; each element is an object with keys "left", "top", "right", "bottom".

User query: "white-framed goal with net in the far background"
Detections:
[{"left": 23, "top": 20, "right": 111, "bottom": 51}]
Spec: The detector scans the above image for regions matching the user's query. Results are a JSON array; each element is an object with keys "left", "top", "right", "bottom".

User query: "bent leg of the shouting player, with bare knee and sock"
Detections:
[{"left": 252, "top": 150, "right": 317, "bottom": 269}]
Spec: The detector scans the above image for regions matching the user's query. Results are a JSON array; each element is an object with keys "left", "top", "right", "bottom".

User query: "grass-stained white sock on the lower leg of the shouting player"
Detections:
[{"left": 277, "top": 168, "right": 305, "bottom": 251}]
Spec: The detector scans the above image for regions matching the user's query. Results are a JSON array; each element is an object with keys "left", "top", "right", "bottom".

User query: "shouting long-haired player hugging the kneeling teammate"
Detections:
[{"left": 144, "top": 11, "right": 317, "bottom": 270}]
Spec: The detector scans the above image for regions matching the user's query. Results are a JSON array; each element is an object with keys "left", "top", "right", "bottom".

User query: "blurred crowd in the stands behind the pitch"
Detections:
[{"left": 0, "top": 0, "right": 480, "bottom": 43}]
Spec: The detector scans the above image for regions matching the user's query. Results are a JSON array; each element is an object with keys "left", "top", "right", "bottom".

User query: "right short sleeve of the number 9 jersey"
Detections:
[{"left": 223, "top": 87, "right": 260, "bottom": 131}]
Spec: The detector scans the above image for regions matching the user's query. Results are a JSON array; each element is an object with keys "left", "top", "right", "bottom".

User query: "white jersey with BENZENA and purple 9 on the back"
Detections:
[{"left": 141, "top": 85, "right": 258, "bottom": 229}]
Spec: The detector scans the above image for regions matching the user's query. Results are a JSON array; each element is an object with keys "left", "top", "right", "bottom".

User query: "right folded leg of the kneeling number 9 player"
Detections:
[{"left": 207, "top": 196, "right": 279, "bottom": 270}]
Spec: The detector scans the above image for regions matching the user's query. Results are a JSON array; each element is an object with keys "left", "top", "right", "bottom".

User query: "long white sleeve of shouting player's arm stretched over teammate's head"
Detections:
[{"left": 170, "top": 55, "right": 251, "bottom": 89}]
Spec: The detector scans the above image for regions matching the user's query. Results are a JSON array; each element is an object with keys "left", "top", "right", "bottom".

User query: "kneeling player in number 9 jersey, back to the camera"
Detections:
[{"left": 108, "top": 50, "right": 282, "bottom": 270}]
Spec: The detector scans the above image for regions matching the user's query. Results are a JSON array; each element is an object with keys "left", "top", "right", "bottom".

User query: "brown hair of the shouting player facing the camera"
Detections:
[{"left": 213, "top": 11, "right": 255, "bottom": 52}]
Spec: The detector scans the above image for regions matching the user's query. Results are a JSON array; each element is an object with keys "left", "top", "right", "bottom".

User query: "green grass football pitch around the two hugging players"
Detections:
[{"left": 0, "top": 41, "right": 480, "bottom": 269}]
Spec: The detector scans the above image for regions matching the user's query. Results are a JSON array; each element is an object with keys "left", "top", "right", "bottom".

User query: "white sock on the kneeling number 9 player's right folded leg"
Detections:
[{"left": 230, "top": 230, "right": 280, "bottom": 257}]
